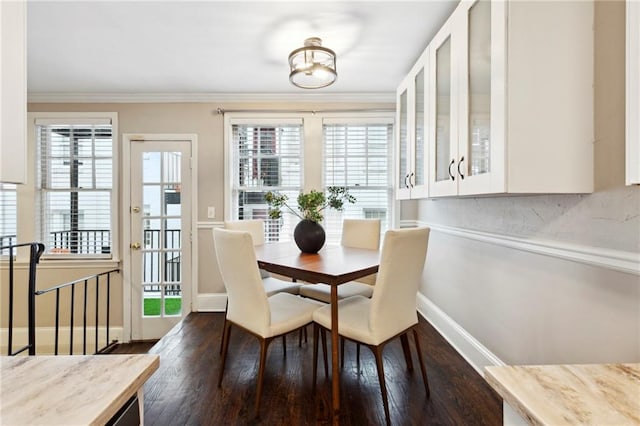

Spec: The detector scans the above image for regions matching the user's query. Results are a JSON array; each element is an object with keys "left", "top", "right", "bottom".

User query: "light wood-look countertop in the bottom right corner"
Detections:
[{"left": 485, "top": 364, "right": 640, "bottom": 426}]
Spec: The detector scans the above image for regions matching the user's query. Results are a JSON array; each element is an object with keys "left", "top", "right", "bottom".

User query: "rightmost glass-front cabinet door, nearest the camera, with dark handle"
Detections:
[{"left": 456, "top": 0, "right": 505, "bottom": 195}]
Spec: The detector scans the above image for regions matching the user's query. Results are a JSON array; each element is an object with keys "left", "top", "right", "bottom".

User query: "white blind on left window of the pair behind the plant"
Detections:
[{"left": 232, "top": 121, "right": 303, "bottom": 242}]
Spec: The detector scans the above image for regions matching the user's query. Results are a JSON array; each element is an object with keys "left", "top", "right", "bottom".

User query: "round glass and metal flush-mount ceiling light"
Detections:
[{"left": 289, "top": 37, "right": 338, "bottom": 89}]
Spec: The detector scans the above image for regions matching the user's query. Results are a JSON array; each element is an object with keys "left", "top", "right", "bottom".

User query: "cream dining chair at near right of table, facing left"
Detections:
[{"left": 313, "top": 227, "right": 429, "bottom": 424}]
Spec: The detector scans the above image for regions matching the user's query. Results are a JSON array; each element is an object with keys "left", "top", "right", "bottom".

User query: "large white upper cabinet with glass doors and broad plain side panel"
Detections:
[{"left": 427, "top": 0, "right": 594, "bottom": 197}]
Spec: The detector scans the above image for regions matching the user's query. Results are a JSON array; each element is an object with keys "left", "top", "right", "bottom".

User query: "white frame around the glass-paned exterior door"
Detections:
[{"left": 120, "top": 133, "right": 198, "bottom": 343}]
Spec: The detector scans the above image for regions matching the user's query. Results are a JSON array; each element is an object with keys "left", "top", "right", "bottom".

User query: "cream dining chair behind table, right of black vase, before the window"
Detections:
[{"left": 300, "top": 219, "right": 380, "bottom": 303}]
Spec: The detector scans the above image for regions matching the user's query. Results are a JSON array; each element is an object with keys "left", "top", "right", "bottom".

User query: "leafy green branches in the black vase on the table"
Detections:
[{"left": 264, "top": 186, "right": 356, "bottom": 222}]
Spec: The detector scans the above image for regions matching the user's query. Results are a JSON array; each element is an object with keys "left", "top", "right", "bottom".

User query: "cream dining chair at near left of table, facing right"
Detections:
[{"left": 213, "top": 229, "right": 322, "bottom": 417}]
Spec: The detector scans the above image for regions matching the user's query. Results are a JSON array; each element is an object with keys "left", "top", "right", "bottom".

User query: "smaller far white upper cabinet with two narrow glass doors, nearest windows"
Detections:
[{"left": 396, "top": 51, "right": 428, "bottom": 200}]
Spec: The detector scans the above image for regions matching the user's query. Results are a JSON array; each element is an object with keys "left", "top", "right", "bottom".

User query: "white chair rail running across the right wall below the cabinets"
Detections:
[{"left": 412, "top": 221, "right": 640, "bottom": 276}]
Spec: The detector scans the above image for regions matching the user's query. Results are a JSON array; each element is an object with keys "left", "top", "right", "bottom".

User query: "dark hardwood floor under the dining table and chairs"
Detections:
[{"left": 113, "top": 313, "right": 502, "bottom": 425}]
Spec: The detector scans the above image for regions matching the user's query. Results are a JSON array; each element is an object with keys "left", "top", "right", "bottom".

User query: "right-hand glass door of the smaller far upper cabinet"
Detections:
[{"left": 409, "top": 64, "right": 428, "bottom": 198}]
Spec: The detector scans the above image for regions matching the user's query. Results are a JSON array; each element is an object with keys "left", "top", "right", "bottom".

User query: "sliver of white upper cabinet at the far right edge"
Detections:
[{"left": 626, "top": 0, "right": 640, "bottom": 185}]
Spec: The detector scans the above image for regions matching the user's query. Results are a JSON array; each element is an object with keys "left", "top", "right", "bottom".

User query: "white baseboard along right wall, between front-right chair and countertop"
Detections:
[{"left": 416, "top": 293, "right": 506, "bottom": 377}]
